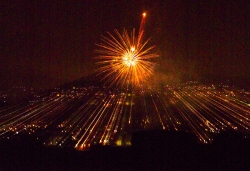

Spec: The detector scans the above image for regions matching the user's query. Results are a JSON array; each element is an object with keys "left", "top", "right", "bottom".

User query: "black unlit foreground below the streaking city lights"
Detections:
[{"left": 0, "top": 131, "right": 250, "bottom": 171}]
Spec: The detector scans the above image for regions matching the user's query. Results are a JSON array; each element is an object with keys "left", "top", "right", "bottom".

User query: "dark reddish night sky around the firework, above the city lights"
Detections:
[{"left": 0, "top": 0, "right": 250, "bottom": 88}]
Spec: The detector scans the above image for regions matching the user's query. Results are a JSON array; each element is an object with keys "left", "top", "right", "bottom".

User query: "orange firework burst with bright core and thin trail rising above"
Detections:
[{"left": 96, "top": 13, "right": 158, "bottom": 86}]
